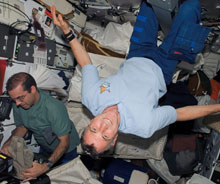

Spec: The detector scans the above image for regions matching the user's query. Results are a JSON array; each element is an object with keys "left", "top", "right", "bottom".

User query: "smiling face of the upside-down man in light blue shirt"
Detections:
[{"left": 83, "top": 106, "right": 120, "bottom": 153}]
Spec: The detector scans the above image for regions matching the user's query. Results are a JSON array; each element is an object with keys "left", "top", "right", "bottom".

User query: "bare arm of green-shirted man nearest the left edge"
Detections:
[{"left": 0, "top": 126, "right": 28, "bottom": 155}]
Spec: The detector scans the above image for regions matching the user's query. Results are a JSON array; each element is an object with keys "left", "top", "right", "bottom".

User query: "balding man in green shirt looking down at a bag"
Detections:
[{"left": 0, "top": 72, "right": 80, "bottom": 181}]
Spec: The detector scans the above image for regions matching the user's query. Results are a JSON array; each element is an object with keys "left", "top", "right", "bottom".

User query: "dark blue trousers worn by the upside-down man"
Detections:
[{"left": 127, "top": 0, "right": 208, "bottom": 85}]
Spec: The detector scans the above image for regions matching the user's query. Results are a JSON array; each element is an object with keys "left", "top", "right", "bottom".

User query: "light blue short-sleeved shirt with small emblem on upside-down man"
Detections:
[{"left": 82, "top": 57, "right": 177, "bottom": 138}]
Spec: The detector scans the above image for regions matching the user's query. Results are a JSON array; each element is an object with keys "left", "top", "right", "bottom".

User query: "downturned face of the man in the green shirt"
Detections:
[{"left": 8, "top": 84, "right": 39, "bottom": 109}]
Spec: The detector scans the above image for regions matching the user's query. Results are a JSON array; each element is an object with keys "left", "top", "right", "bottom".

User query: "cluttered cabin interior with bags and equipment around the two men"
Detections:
[{"left": 0, "top": 0, "right": 220, "bottom": 184}]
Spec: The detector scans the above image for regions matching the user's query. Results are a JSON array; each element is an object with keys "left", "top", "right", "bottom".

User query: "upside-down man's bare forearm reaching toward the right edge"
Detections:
[{"left": 176, "top": 104, "right": 220, "bottom": 121}]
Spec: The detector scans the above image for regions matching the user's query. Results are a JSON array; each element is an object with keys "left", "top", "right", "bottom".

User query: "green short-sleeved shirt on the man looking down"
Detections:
[{"left": 13, "top": 90, "right": 80, "bottom": 153}]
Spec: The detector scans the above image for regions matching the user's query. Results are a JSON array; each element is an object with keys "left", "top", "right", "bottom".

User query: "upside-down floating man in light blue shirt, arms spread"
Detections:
[{"left": 51, "top": 0, "right": 217, "bottom": 155}]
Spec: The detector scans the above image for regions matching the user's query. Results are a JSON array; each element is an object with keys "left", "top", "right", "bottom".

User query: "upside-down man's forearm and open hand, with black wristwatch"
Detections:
[{"left": 51, "top": 6, "right": 91, "bottom": 67}]
